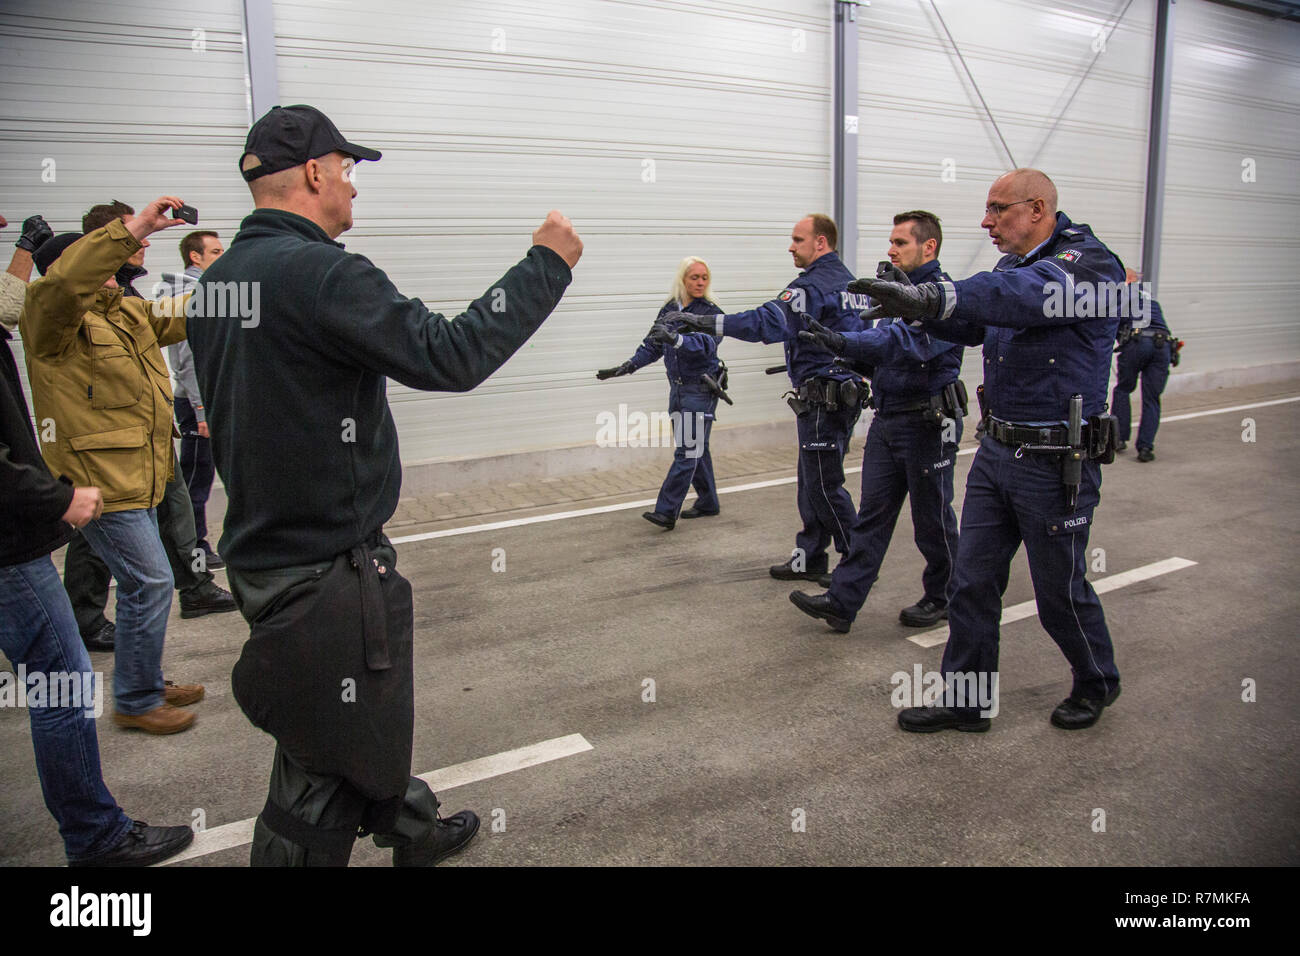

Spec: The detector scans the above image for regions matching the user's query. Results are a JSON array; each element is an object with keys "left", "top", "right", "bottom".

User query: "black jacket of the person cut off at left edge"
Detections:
[{"left": 0, "top": 326, "right": 73, "bottom": 567}]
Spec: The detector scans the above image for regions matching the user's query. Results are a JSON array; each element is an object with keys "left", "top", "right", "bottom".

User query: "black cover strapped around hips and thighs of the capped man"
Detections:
[{"left": 230, "top": 545, "right": 415, "bottom": 832}]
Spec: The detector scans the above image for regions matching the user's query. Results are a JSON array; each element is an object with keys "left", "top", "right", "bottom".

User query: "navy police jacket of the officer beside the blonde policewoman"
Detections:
[{"left": 718, "top": 252, "right": 868, "bottom": 386}]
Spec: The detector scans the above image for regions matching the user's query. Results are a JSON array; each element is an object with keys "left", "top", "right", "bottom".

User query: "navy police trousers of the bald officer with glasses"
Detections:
[{"left": 943, "top": 437, "right": 1119, "bottom": 700}]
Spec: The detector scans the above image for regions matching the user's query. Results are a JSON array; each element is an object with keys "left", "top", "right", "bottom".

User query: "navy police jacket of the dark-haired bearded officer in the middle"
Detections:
[{"left": 844, "top": 259, "right": 966, "bottom": 412}]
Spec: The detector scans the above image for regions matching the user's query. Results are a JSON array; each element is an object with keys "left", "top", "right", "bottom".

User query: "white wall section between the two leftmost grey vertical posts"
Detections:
[{"left": 276, "top": 0, "right": 831, "bottom": 462}]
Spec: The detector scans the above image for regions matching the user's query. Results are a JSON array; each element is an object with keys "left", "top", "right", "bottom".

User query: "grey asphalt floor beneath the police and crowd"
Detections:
[{"left": 0, "top": 381, "right": 1300, "bottom": 866}]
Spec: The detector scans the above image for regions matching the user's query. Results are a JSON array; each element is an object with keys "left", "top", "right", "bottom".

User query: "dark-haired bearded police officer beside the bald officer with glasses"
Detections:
[{"left": 790, "top": 209, "right": 963, "bottom": 633}]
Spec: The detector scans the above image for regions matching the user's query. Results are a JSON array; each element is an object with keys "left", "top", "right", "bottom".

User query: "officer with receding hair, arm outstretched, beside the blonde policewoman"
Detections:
[{"left": 664, "top": 213, "right": 867, "bottom": 587}]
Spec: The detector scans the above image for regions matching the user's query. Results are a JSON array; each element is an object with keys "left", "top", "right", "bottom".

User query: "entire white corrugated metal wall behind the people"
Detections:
[{"left": 0, "top": 0, "right": 1300, "bottom": 462}]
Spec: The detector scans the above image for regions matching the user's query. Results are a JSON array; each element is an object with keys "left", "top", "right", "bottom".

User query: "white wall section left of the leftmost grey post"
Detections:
[{"left": 0, "top": 0, "right": 248, "bottom": 424}]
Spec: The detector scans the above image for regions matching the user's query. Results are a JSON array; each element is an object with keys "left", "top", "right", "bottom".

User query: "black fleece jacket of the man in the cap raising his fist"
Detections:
[{"left": 187, "top": 209, "right": 572, "bottom": 571}]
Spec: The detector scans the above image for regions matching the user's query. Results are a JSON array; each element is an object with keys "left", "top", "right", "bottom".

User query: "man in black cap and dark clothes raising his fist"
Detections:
[{"left": 189, "top": 105, "right": 582, "bottom": 866}]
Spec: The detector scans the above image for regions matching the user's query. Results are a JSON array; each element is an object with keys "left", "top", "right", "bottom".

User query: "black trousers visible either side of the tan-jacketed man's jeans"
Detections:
[{"left": 64, "top": 462, "right": 212, "bottom": 637}]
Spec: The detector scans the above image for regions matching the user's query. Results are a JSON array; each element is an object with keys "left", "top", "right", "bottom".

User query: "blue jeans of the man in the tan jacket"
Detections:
[{"left": 82, "top": 509, "right": 173, "bottom": 714}]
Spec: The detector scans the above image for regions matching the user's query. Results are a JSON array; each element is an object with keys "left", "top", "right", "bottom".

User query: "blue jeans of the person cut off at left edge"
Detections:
[{"left": 0, "top": 554, "right": 131, "bottom": 862}]
